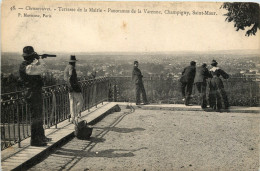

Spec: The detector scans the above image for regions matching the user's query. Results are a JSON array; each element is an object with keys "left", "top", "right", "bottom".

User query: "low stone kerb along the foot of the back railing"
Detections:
[{"left": 117, "top": 102, "right": 260, "bottom": 113}]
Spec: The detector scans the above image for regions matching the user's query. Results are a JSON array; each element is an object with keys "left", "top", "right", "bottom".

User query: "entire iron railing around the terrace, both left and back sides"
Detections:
[{"left": 1, "top": 77, "right": 260, "bottom": 150}]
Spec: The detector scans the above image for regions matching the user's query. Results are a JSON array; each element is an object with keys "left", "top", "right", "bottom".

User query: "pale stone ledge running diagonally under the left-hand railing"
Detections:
[{"left": 1, "top": 102, "right": 119, "bottom": 171}]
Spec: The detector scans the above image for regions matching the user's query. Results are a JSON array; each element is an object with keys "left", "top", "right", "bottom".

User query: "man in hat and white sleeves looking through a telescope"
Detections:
[{"left": 19, "top": 46, "right": 51, "bottom": 146}]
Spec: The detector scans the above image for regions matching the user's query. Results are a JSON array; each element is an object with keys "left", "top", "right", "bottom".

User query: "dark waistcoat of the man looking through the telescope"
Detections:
[{"left": 19, "top": 61, "right": 44, "bottom": 91}]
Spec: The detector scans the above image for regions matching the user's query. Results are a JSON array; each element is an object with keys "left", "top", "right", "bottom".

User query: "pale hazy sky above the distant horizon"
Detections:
[{"left": 1, "top": 1, "right": 260, "bottom": 53}]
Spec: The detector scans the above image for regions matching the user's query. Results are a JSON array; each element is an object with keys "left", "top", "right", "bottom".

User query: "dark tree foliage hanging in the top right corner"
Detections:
[{"left": 221, "top": 2, "right": 260, "bottom": 36}]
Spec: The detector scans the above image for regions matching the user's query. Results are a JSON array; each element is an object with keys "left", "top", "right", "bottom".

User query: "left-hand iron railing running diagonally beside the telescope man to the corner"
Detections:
[{"left": 1, "top": 77, "right": 109, "bottom": 150}]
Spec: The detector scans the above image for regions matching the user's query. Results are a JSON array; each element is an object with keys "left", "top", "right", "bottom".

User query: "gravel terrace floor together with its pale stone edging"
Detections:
[{"left": 1, "top": 103, "right": 260, "bottom": 171}]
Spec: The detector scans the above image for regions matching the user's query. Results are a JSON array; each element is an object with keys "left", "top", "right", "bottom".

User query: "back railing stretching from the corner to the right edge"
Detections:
[{"left": 110, "top": 76, "right": 260, "bottom": 106}]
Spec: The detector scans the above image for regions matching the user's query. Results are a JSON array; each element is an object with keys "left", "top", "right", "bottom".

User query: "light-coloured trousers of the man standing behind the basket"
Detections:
[{"left": 69, "top": 92, "right": 83, "bottom": 121}]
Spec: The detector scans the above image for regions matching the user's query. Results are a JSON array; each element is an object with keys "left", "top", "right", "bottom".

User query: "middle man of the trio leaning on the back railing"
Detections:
[{"left": 194, "top": 63, "right": 212, "bottom": 109}]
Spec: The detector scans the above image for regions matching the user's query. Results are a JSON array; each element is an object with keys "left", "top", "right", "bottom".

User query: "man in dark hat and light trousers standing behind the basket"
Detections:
[{"left": 64, "top": 55, "right": 83, "bottom": 123}]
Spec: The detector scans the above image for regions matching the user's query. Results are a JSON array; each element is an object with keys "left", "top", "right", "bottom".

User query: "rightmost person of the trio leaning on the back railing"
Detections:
[{"left": 209, "top": 60, "right": 229, "bottom": 110}]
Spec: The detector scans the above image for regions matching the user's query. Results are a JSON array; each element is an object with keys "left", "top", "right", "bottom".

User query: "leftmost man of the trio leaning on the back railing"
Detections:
[{"left": 180, "top": 61, "right": 196, "bottom": 106}]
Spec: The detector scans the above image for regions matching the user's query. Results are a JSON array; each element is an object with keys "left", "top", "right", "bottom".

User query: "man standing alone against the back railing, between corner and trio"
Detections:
[{"left": 132, "top": 61, "right": 148, "bottom": 105}]
